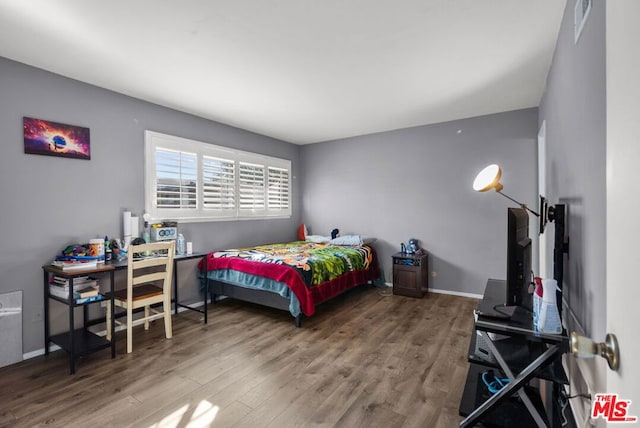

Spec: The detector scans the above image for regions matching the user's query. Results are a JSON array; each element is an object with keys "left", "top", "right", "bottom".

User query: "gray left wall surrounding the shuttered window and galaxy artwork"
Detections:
[{"left": 0, "top": 58, "right": 300, "bottom": 353}]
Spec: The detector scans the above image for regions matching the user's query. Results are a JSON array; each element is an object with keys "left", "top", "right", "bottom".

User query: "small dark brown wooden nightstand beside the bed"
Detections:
[{"left": 392, "top": 250, "right": 429, "bottom": 297}]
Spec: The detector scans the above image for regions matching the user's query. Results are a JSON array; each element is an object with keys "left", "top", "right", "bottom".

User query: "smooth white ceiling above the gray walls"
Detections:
[{"left": 0, "top": 0, "right": 565, "bottom": 144}]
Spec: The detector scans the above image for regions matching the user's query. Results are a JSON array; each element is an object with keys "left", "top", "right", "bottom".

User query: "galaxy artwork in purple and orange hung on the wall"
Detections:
[{"left": 22, "top": 117, "right": 91, "bottom": 159}]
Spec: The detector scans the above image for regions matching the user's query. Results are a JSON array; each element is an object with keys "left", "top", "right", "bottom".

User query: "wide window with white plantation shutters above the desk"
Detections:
[{"left": 145, "top": 131, "right": 291, "bottom": 221}]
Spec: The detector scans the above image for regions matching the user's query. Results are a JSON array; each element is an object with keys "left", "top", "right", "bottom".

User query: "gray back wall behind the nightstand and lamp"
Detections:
[{"left": 301, "top": 108, "right": 538, "bottom": 294}]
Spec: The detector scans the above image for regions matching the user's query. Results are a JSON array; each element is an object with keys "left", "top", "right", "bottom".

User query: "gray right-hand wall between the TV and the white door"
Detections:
[{"left": 539, "top": 1, "right": 606, "bottom": 338}]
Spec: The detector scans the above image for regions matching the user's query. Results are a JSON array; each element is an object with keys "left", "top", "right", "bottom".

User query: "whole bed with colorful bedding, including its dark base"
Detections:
[{"left": 200, "top": 241, "right": 380, "bottom": 327}]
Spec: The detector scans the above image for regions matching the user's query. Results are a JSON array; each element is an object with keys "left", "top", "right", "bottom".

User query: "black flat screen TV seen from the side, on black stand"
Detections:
[{"left": 505, "top": 208, "right": 532, "bottom": 309}]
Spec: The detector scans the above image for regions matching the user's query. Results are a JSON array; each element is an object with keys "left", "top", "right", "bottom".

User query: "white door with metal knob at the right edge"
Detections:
[{"left": 608, "top": 0, "right": 640, "bottom": 420}]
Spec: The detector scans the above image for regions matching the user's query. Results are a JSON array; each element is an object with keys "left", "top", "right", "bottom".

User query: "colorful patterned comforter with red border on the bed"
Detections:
[{"left": 206, "top": 241, "right": 379, "bottom": 316}]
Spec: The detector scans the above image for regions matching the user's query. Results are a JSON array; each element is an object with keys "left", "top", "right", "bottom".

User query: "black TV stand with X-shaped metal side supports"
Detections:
[{"left": 460, "top": 280, "right": 569, "bottom": 427}]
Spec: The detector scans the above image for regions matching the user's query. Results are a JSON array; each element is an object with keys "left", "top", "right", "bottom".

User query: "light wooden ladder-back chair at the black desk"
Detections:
[{"left": 107, "top": 241, "right": 175, "bottom": 353}]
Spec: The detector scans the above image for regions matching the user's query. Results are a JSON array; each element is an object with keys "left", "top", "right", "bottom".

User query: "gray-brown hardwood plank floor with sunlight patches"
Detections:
[{"left": 0, "top": 287, "right": 477, "bottom": 428}]
